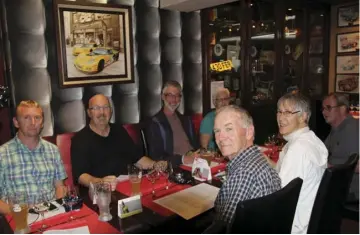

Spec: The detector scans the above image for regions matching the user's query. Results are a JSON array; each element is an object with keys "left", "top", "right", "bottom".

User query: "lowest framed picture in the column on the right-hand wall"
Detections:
[{"left": 335, "top": 74, "right": 359, "bottom": 93}]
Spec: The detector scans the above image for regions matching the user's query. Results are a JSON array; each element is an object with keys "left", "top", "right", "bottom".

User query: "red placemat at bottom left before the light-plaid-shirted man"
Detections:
[{"left": 6, "top": 204, "right": 121, "bottom": 233}]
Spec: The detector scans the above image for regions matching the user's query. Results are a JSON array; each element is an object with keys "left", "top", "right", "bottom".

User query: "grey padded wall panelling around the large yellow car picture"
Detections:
[{"left": 2, "top": 0, "right": 202, "bottom": 136}]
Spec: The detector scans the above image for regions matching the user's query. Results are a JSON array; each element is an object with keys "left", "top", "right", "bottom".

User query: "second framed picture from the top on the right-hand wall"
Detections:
[{"left": 336, "top": 32, "right": 359, "bottom": 53}]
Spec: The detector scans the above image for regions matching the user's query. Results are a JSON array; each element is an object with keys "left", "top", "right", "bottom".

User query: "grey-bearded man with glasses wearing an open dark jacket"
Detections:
[{"left": 146, "top": 81, "right": 198, "bottom": 166}]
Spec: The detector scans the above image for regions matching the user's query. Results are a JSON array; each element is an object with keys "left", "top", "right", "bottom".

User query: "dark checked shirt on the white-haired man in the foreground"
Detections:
[{"left": 215, "top": 145, "right": 281, "bottom": 223}]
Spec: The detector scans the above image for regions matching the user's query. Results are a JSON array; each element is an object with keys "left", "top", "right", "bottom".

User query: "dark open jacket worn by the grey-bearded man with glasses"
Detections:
[{"left": 145, "top": 110, "right": 199, "bottom": 167}]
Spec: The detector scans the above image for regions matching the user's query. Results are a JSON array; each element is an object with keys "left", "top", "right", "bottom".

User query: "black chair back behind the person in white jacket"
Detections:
[{"left": 307, "top": 154, "right": 359, "bottom": 233}]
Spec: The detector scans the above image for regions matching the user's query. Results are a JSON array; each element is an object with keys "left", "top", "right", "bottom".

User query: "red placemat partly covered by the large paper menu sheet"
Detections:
[{"left": 141, "top": 184, "right": 191, "bottom": 216}]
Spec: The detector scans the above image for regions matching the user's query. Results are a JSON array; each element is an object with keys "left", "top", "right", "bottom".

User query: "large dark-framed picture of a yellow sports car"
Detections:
[{"left": 54, "top": 0, "right": 134, "bottom": 88}]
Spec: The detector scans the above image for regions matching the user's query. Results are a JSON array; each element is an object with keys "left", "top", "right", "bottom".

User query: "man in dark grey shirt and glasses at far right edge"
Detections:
[{"left": 322, "top": 93, "right": 359, "bottom": 201}]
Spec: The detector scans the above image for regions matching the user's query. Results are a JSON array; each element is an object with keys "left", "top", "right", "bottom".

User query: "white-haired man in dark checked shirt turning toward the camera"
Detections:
[{"left": 214, "top": 105, "right": 281, "bottom": 223}]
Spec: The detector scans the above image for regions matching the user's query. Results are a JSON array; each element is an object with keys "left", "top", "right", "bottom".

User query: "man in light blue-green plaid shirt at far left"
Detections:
[{"left": 0, "top": 100, "right": 67, "bottom": 214}]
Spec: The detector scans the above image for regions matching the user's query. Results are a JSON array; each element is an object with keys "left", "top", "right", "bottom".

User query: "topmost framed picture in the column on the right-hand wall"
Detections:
[{"left": 337, "top": 4, "right": 359, "bottom": 27}]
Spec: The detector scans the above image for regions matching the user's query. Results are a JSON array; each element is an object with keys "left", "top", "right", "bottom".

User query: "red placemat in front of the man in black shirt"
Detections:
[{"left": 116, "top": 176, "right": 167, "bottom": 196}]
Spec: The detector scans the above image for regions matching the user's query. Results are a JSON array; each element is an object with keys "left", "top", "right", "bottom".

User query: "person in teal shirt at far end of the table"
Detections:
[{"left": 200, "top": 88, "right": 230, "bottom": 150}]
